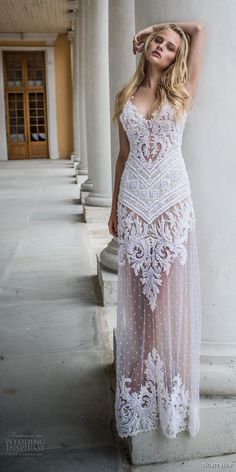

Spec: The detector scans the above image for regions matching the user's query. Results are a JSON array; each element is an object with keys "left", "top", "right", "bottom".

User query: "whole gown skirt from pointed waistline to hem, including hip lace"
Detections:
[{"left": 115, "top": 196, "right": 201, "bottom": 438}]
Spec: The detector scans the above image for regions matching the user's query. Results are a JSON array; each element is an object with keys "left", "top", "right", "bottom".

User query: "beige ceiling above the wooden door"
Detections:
[{"left": 0, "top": 0, "right": 77, "bottom": 33}]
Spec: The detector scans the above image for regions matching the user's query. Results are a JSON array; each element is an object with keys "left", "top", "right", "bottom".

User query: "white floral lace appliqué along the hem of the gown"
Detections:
[{"left": 116, "top": 348, "right": 197, "bottom": 438}]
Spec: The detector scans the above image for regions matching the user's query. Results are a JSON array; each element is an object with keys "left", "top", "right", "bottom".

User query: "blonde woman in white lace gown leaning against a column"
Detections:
[{"left": 108, "top": 22, "right": 205, "bottom": 438}]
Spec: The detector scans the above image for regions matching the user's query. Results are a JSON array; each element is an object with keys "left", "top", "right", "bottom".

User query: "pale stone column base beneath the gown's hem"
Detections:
[{"left": 129, "top": 397, "right": 236, "bottom": 465}]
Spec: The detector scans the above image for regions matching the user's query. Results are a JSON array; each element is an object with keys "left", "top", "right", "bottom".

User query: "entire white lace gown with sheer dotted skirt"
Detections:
[{"left": 115, "top": 98, "right": 201, "bottom": 438}]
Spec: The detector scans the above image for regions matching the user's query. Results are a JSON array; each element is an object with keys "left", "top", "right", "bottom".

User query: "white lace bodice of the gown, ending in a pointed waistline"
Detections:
[{"left": 119, "top": 100, "right": 191, "bottom": 223}]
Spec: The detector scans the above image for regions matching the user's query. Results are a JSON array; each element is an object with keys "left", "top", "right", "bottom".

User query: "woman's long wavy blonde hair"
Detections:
[{"left": 112, "top": 23, "right": 191, "bottom": 123}]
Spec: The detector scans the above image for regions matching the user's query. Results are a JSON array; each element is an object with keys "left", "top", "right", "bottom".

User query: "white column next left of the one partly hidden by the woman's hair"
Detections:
[{"left": 84, "top": 0, "right": 111, "bottom": 208}]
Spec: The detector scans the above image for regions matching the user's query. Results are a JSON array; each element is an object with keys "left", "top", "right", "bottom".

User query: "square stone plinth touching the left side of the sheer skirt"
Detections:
[{"left": 96, "top": 253, "right": 117, "bottom": 306}]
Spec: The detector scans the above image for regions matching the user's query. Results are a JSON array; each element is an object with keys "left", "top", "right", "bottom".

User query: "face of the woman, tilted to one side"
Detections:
[{"left": 146, "top": 29, "right": 181, "bottom": 70}]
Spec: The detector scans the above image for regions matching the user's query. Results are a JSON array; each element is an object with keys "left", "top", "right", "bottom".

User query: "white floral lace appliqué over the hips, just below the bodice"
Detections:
[{"left": 118, "top": 197, "right": 195, "bottom": 310}]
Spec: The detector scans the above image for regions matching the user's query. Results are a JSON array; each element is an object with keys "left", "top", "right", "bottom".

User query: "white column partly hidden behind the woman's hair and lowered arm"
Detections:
[{"left": 100, "top": 0, "right": 136, "bottom": 272}]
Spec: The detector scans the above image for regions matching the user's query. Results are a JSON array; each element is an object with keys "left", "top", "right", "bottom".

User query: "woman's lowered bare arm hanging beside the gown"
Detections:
[{"left": 108, "top": 121, "right": 130, "bottom": 236}]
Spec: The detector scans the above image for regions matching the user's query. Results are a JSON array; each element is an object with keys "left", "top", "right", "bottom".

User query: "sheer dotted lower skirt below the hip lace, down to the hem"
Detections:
[{"left": 116, "top": 203, "right": 200, "bottom": 438}]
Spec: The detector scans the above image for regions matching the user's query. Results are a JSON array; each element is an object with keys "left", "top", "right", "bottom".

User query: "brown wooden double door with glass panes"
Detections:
[{"left": 4, "top": 51, "right": 48, "bottom": 159}]
